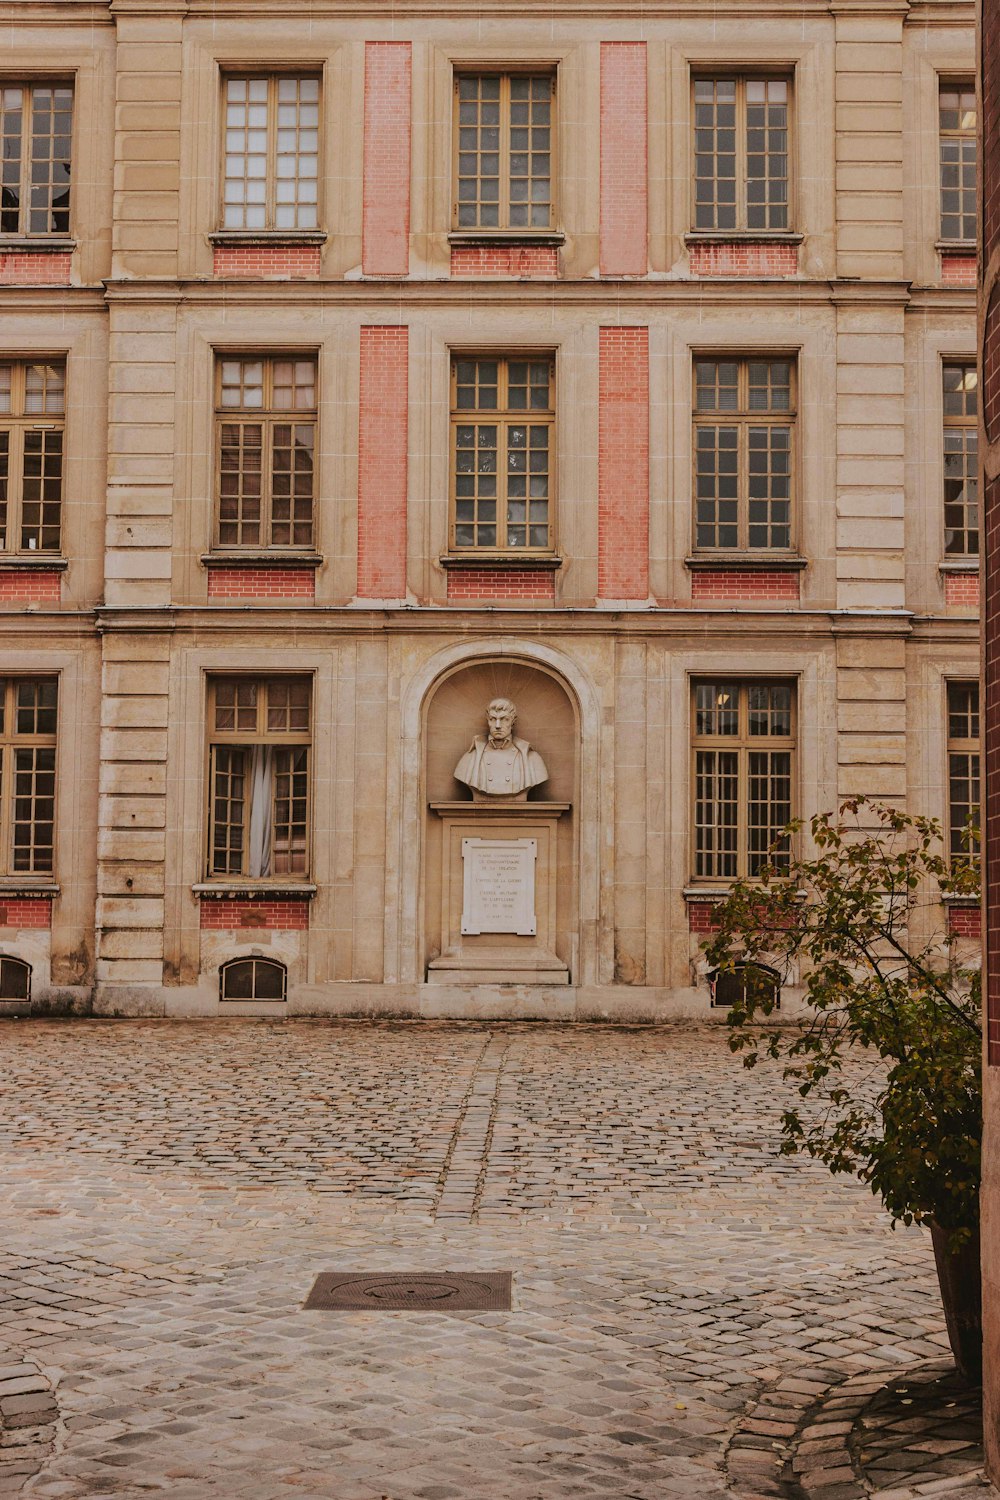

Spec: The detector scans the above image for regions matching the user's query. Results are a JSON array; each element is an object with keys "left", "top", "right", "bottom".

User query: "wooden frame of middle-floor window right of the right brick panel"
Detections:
[{"left": 691, "top": 350, "right": 799, "bottom": 558}]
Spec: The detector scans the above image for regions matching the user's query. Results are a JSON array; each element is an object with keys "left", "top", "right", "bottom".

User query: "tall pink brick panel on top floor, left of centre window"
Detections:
[{"left": 361, "top": 42, "right": 411, "bottom": 276}]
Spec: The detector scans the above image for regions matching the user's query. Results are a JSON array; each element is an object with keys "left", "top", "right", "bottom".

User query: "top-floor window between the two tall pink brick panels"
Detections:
[{"left": 454, "top": 74, "right": 555, "bottom": 231}]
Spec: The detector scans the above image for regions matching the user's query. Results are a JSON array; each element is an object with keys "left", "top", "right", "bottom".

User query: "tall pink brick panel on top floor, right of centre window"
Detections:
[{"left": 601, "top": 42, "right": 648, "bottom": 276}]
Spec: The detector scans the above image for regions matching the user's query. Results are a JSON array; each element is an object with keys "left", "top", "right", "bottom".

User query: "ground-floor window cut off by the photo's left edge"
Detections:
[{"left": 0, "top": 677, "right": 58, "bottom": 875}]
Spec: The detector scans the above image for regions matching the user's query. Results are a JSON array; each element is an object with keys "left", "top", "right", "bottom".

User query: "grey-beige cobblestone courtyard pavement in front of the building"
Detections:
[{"left": 0, "top": 1022, "right": 990, "bottom": 1500}]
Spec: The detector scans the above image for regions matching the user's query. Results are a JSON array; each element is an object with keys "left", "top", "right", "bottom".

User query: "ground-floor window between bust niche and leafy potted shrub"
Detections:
[{"left": 693, "top": 681, "right": 795, "bottom": 881}]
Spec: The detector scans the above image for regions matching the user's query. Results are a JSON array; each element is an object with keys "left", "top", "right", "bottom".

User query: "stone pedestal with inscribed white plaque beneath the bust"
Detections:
[{"left": 427, "top": 798, "right": 570, "bottom": 984}]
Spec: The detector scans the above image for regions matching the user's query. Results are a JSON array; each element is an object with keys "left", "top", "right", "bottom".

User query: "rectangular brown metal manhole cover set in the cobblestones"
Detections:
[{"left": 306, "top": 1271, "right": 511, "bottom": 1313}]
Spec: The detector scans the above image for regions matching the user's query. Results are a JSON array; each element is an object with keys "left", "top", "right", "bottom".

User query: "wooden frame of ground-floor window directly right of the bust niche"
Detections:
[{"left": 688, "top": 674, "right": 799, "bottom": 888}]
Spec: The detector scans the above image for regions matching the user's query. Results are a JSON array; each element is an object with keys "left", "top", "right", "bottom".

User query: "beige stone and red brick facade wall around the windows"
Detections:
[{"left": 0, "top": 0, "right": 978, "bottom": 1017}]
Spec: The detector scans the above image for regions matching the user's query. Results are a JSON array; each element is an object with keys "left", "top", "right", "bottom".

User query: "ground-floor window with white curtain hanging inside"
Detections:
[{"left": 208, "top": 677, "right": 312, "bottom": 881}]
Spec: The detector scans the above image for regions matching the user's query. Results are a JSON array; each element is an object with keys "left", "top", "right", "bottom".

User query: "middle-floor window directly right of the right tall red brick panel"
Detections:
[{"left": 694, "top": 359, "right": 796, "bottom": 551}]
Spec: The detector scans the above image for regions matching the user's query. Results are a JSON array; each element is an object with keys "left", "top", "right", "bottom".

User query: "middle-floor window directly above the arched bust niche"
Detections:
[{"left": 451, "top": 357, "right": 555, "bottom": 552}]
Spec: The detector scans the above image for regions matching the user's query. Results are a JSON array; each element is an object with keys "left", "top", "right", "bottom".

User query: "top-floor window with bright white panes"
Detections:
[{"left": 222, "top": 75, "right": 319, "bottom": 230}]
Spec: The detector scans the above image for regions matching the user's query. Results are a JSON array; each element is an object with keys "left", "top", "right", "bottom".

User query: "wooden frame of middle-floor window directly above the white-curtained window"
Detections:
[{"left": 211, "top": 350, "right": 319, "bottom": 554}]
